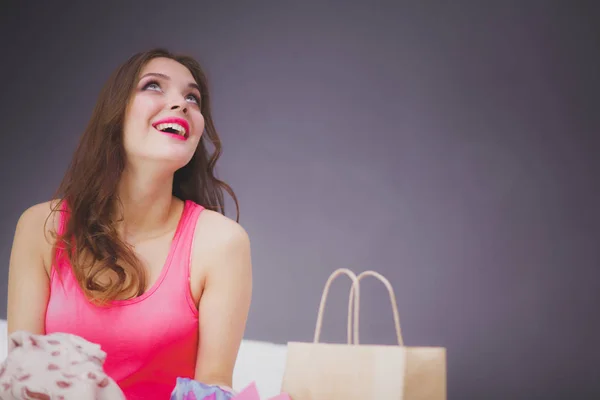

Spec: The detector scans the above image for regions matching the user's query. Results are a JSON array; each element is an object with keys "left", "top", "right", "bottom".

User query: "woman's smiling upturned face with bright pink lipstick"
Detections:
[{"left": 123, "top": 58, "right": 204, "bottom": 171}]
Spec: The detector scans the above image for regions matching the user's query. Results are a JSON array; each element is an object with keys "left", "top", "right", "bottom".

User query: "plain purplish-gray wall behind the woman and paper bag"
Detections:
[{"left": 0, "top": 1, "right": 600, "bottom": 400}]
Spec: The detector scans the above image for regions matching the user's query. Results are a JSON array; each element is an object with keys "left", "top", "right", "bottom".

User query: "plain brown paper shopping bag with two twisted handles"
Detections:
[{"left": 282, "top": 268, "right": 446, "bottom": 400}]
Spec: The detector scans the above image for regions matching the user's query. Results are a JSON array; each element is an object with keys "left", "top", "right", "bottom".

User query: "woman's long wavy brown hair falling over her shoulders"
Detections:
[{"left": 53, "top": 48, "right": 239, "bottom": 304}]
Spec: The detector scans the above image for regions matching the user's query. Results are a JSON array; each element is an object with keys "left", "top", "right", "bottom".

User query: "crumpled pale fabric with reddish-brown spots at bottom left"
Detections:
[{"left": 0, "top": 331, "right": 125, "bottom": 400}]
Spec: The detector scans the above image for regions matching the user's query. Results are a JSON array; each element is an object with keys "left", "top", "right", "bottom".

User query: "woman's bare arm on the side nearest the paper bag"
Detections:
[{"left": 190, "top": 211, "right": 252, "bottom": 387}]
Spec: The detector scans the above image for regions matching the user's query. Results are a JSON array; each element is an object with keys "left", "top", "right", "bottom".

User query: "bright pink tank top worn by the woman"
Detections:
[{"left": 46, "top": 200, "right": 204, "bottom": 400}]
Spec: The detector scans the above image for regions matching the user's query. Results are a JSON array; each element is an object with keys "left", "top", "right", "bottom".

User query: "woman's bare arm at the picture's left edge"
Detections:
[{"left": 7, "top": 203, "right": 52, "bottom": 334}]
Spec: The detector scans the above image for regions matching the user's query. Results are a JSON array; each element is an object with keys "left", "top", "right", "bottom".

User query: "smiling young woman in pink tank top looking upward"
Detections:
[{"left": 8, "top": 49, "right": 252, "bottom": 399}]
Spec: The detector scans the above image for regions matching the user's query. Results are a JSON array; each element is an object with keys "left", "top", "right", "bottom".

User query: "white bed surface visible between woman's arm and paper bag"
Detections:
[{"left": 0, "top": 320, "right": 286, "bottom": 399}]
